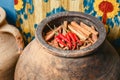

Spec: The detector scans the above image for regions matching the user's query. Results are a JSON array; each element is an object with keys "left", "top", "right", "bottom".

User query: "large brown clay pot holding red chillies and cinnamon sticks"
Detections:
[{"left": 15, "top": 12, "right": 120, "bottom": 80}]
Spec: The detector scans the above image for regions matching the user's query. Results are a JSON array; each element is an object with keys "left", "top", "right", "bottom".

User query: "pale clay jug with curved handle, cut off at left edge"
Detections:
[{"left": 0, "top": 7, "right": 24, "bottom": 80}]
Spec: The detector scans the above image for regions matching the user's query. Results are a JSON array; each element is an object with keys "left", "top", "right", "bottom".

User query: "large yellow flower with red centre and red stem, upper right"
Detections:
[{"left": 94, "top": 0, "right": 119, "bottom": 24}]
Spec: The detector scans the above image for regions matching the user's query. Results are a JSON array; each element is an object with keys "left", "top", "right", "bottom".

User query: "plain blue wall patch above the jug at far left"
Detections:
[{"left": 0, "top": 0, "right": 16, "bottom": 25}]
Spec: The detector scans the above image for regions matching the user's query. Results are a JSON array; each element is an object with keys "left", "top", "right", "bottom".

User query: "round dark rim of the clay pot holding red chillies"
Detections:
[{"left": 35, "top": 11, "right": 106, "bottom": 58}]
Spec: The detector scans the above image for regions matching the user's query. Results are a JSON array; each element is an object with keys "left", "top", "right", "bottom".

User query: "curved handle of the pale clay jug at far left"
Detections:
[{"left": 0, "top": 24, "right": 24, "bottom": 53}]
